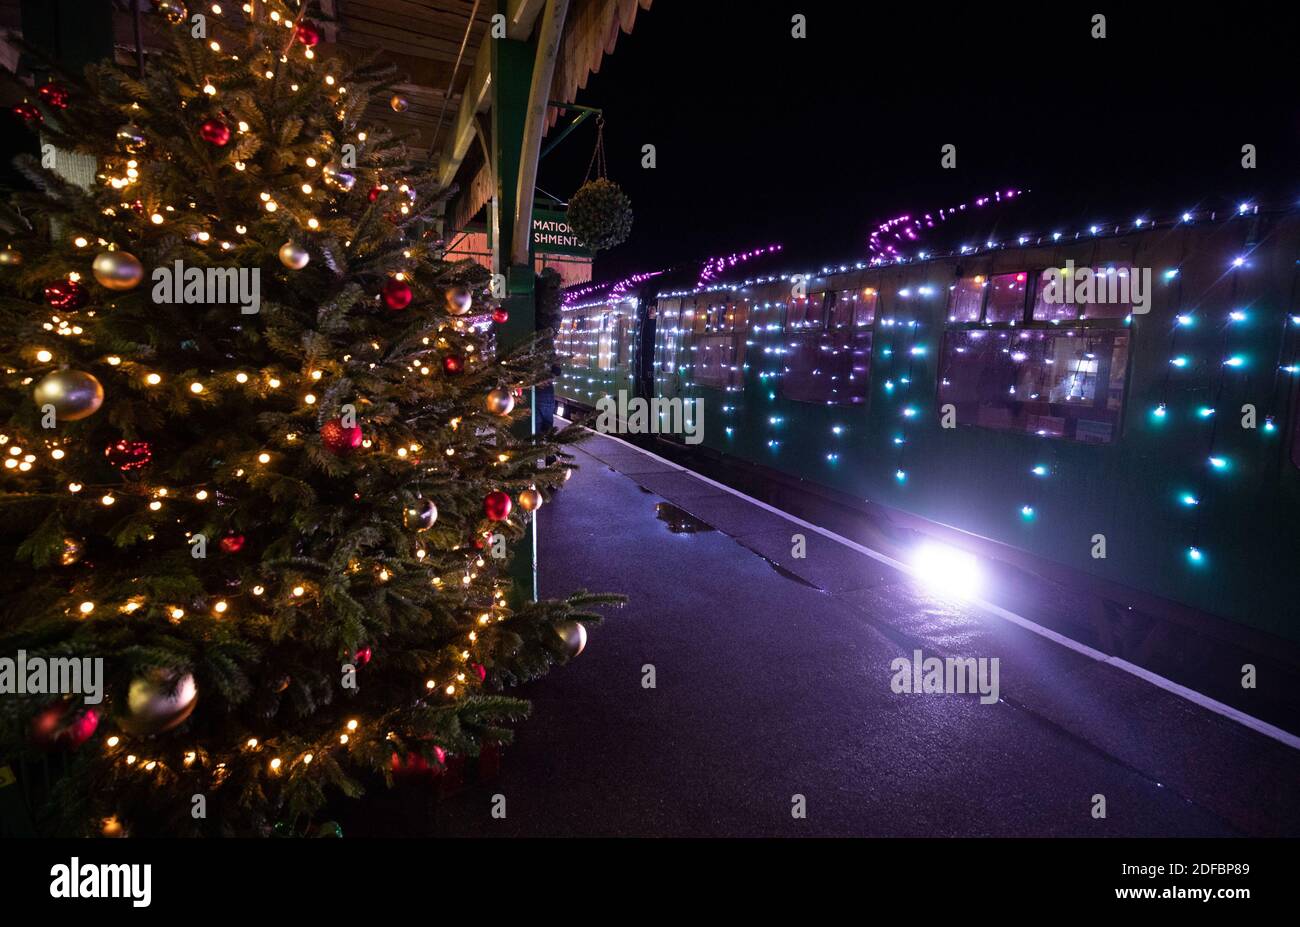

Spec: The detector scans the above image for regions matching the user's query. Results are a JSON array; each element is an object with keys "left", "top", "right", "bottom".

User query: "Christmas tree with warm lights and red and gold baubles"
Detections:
[{"left": 0, "top": 1, "right": 614, "bottom": 835}]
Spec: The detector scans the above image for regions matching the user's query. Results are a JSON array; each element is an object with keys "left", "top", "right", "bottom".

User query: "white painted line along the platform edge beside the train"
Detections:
[{"left": 555, "top": 415, "right": 1300, "bottom": 750}]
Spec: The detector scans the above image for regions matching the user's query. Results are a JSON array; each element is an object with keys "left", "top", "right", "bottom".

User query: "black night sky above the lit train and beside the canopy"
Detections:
[{"left": 538, "top": 0, "right": 1300, "bottom": 281}]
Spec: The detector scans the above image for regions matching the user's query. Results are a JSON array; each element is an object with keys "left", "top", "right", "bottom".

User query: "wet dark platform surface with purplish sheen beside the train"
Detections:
[{"left": 437, "top": 436, "right": 1300, "bottom": 836}]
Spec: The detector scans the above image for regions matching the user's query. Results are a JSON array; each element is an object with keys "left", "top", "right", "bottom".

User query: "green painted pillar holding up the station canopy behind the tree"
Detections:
[{"left": 489, "top": 12, "right": 541, "bottom": 605}]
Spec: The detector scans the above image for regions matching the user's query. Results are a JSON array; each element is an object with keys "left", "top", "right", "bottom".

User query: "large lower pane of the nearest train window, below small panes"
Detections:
[{"left": 939, "top": 329, "right": 1128, "bottom": 445}]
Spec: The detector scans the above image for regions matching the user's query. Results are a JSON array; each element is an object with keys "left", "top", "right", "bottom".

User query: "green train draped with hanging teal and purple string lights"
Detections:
[{"left": 558, "top": 207, "right": 1300, "bottom": 644}]
